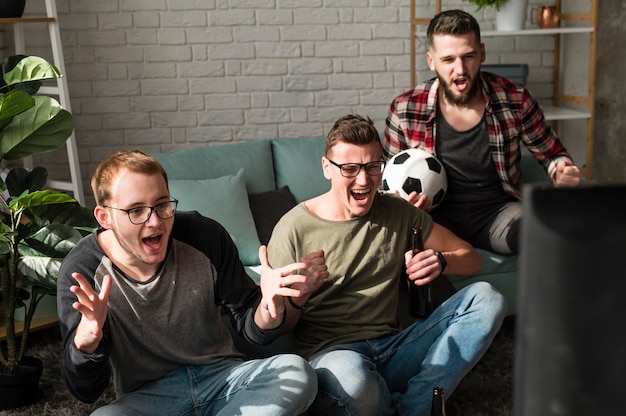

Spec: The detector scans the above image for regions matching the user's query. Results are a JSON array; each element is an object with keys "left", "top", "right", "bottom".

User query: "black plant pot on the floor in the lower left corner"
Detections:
[{"left": 0, "top": 357, "right": 43, "bottom": 410}]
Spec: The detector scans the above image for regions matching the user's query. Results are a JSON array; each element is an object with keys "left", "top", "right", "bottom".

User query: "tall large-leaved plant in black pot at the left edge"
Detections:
[{"left": 0, "top": 55, "right": 97, "bottom": 409}]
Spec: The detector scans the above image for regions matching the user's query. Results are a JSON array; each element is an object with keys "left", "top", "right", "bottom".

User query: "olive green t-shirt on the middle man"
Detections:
[{"left": 268, "top": 194, "right": 432, "bottom": 357}]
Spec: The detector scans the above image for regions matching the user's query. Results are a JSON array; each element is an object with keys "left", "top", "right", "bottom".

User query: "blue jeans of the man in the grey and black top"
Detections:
[{"left": 92, "top": 354, "right": 317, "bottom": 416}]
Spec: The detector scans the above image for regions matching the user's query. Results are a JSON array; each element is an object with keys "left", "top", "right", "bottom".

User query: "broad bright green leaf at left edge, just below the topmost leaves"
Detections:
[{"left": 0, "top": 96, "right": 74, "bottom": 160}]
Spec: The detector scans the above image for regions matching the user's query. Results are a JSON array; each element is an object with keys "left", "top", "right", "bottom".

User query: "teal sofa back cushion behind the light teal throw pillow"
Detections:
[{"left": 152, "top": 140, "right": 276, "bottom": 194}]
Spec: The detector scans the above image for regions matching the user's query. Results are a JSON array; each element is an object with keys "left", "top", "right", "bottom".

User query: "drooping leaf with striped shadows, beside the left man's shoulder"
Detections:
[{"left": 18, "top": 224, "right": 83, "bottom": 289}]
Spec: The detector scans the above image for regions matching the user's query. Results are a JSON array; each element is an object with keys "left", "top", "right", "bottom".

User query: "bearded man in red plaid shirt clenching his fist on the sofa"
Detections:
[{"left": 383, "top": 10, "right": 581, "bottom": 254}]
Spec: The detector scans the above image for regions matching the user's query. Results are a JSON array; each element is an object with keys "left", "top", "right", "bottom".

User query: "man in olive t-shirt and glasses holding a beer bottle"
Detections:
[{"left": 268, "top": 115, "right": 505, "bottom": 416}]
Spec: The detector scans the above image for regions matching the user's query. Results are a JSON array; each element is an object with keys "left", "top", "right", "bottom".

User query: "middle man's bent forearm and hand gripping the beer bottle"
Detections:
[{"left": 405, "top": 222, "right": 483, "bottom": 284}]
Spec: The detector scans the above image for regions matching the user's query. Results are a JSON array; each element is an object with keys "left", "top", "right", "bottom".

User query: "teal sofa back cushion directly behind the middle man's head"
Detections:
[{"left": 272, "top": 137, "right": 330, "bottom": 202}]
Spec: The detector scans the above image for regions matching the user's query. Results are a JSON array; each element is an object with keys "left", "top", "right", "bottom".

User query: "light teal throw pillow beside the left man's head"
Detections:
[{"left": 169, "top": 169, "right": 261, "bottom": 265}]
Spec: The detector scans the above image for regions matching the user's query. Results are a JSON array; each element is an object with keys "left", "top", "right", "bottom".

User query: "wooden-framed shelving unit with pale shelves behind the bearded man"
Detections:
[{"left": 410, "top": 0, "right": 598, "bottom": 179}]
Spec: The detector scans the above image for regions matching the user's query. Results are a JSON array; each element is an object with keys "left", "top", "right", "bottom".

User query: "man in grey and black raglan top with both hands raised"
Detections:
[{"left": 58, "top": 151, "right": 316, "bottom": 416}]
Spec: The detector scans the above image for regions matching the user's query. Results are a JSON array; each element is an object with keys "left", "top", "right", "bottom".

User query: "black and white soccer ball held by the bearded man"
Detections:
[{"left": 383, "top": 149, "right": 448, "bottom": 208}]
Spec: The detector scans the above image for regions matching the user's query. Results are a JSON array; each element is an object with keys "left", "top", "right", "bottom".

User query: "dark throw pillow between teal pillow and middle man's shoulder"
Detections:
[{"left": 249, "top": 186, "right": 296, "bottom": 244}]
